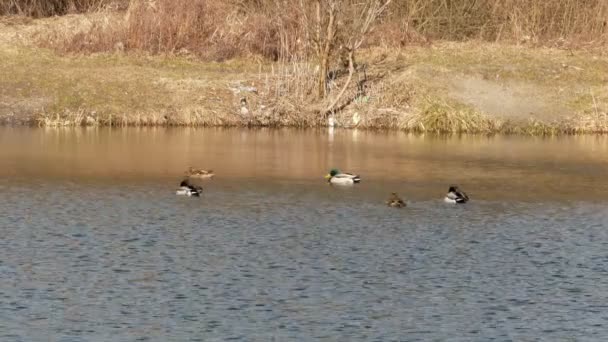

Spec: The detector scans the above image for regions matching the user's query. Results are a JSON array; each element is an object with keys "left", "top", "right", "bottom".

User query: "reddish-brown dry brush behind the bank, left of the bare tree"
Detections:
[{"left": 49, "top": 0, "right": 300, "bottom": 61}]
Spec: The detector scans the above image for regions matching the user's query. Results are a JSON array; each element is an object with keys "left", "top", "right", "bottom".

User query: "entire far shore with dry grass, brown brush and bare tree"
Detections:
[{"left": 0, "top": 0, "right": 608, "bottom": 135}]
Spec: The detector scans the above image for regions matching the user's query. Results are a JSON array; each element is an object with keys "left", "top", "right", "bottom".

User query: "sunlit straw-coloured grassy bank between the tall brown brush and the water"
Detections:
[{"left": 0, "top": 16, "right": 608, "bottom": 134}]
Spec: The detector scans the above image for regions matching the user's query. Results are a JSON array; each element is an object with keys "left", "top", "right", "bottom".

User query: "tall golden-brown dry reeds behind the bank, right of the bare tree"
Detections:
[{"left": 383, "top": 0, "right": 608, "bottom": 44}]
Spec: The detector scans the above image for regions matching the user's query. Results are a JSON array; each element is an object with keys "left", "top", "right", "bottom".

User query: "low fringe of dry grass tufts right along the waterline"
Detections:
[{"left": 29, "top": 100, "right": 608, "bottom": 136}]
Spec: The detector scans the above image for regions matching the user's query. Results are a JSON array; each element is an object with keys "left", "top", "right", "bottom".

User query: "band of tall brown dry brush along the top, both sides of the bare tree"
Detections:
[{"left": 30, "top": 0, "right": 608, "bottom": 61}]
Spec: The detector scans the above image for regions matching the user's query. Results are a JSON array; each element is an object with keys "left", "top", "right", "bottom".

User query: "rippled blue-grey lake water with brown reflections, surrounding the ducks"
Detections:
[{"left": 0, "top": 128, "right": 608, "bottom": 342}]
